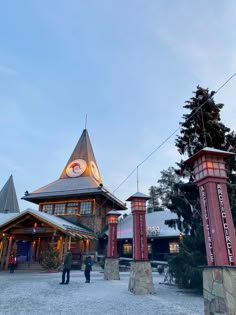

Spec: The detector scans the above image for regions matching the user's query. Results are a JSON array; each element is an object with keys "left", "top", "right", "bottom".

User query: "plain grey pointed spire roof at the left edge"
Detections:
[{"left": 0, "top": 175, "right": 20, "bottom": 213}]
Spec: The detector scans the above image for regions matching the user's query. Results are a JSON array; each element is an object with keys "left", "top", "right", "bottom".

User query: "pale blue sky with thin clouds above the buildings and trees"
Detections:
[{"left": 0, "top": 0, "right": 236, "bottom": 210}]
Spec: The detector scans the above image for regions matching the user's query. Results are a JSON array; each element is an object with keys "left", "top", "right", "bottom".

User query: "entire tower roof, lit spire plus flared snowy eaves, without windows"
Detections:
[{"left": 22, "top": 129, "right": 126, "bottom": 209}]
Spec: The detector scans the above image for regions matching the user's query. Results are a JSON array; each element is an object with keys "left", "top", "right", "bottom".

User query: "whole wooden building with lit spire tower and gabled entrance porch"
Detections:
[{"left": 0, "top": 129, "right": 126, "bottom": 269}]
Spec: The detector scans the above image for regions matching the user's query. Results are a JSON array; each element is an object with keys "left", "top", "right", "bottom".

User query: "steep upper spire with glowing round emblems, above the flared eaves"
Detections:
[{"left": 60, "top": 129, "right": 102, "bottom": 184}]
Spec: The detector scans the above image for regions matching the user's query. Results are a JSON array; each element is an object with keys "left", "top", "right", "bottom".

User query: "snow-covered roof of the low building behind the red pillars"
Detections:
[{"left": 117, "top": 210, "right": 180, "bottom": 239}]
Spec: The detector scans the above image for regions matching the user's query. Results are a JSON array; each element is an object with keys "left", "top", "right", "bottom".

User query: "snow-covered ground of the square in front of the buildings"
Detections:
[{"left": 0, "top": 271, "right": 204, "bottom": 315}]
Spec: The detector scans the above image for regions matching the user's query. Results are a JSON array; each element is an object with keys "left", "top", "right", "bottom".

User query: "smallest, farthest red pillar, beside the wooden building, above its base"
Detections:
[{"left": 107, "top": 210, "right": 120, "bottom": 258}]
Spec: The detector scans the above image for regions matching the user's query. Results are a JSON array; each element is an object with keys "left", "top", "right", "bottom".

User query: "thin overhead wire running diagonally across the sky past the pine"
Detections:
[{"left": 113, "top": 72, "right": 236, "bottom": 193}]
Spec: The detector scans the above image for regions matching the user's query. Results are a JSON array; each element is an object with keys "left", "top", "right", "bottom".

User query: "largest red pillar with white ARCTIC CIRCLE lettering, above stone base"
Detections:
[{"left": 186, "top": 148, "right": 236, "bottom": 266}]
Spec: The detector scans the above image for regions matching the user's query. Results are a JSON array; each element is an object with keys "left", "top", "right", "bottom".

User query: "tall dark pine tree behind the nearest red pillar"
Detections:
[{"left": 168, "top": 86, "right": 236, "bottom": 289}]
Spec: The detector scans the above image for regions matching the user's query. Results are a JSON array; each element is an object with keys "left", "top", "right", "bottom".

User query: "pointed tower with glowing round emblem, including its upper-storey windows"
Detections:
[{"left": 22, "top": 129, "right": 126, "bottom": 227}]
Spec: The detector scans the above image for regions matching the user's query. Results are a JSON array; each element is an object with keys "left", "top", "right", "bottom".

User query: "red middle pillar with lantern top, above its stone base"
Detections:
[{"left": 127, "top": 192, "right": 150, "bottom": 261}]
